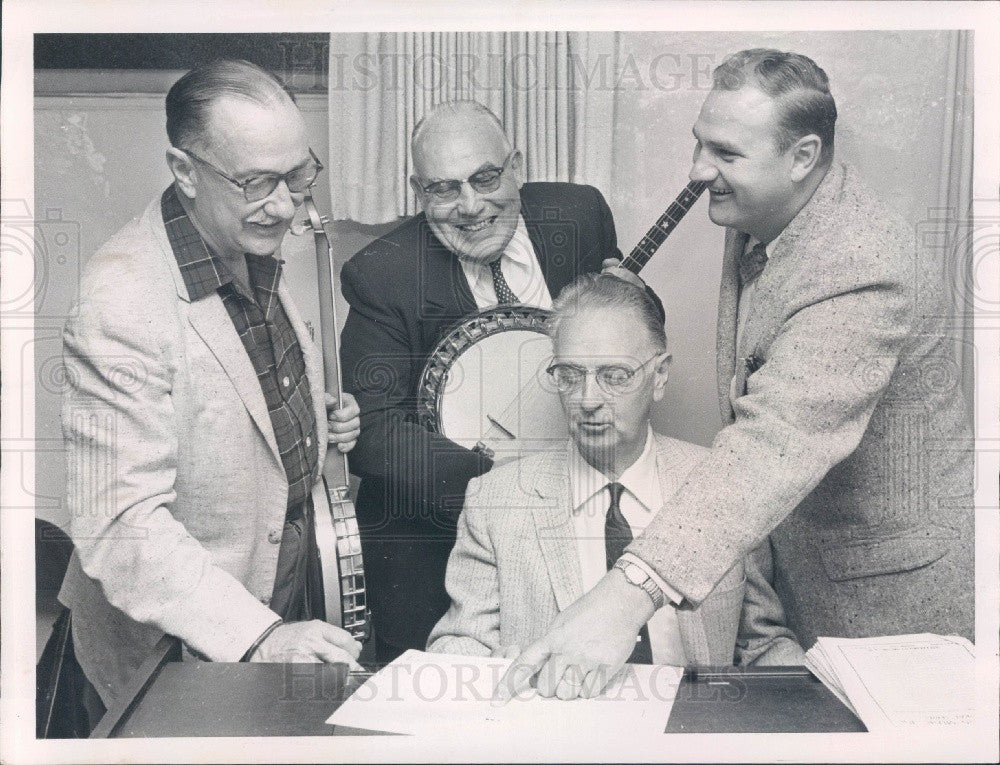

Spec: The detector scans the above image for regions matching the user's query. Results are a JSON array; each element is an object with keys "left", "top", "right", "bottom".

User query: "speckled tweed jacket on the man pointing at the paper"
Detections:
[{"left": 630, "top": 165, "right": 973, "bottom": 646}]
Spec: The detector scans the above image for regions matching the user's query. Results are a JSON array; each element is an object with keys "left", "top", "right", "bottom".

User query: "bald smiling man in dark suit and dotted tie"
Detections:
[{"left": 341, "top": 101, "right": 621, "bottom": 661}]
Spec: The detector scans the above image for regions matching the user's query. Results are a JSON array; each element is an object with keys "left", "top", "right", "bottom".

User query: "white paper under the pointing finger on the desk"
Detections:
[{"left": 327, "top": 651, "right": 683, "bottom": 738}]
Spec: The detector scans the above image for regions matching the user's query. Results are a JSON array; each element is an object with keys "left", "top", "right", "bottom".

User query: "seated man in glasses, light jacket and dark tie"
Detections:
[{"left": 428, "top": 274, "right": 803, "bottom": 696}]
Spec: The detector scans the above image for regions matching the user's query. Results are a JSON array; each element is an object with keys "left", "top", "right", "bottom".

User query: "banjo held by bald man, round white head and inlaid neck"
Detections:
[{"left": 417, "top": 181, "right": 705, "bottom": 460}]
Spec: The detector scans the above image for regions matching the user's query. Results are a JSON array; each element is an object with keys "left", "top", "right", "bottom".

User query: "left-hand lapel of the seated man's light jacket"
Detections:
[{"left": 531, "top": 449, "right": 583, "bottom": 611}]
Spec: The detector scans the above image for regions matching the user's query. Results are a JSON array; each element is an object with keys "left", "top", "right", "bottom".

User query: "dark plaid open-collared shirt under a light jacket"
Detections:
[{"left": 160, "top": 185, "right": 319, "bottom": 515}]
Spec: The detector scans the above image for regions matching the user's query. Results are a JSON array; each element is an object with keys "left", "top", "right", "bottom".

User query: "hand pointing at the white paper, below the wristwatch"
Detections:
[{"left": 493, "top": 568, "right": 655, "bottom": 704}]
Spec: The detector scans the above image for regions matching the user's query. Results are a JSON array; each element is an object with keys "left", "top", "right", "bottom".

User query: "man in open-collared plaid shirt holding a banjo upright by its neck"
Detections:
[{"left": 59, "top": 60, "right": 361, "bottom": 734}]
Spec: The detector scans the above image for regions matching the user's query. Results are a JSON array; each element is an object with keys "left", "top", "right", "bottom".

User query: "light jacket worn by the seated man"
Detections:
[{"left": 428, "top": 435, "right": 803, "bottom": 665}]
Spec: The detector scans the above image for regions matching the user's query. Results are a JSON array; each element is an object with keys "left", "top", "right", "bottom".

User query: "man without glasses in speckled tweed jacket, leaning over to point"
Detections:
[{"left": 500, "top": 50, "right": 974, "bottom": 695}]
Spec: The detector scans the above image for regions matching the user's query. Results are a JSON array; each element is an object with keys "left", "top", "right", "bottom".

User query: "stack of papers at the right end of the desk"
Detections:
[{"left": 806, "top": 634, "right": 975, "bottom": 731}]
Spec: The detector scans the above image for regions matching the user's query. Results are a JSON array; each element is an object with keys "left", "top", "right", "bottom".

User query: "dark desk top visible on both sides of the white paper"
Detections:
[{"left": 93, "top": 649, "right": 865, "bottom": 738}]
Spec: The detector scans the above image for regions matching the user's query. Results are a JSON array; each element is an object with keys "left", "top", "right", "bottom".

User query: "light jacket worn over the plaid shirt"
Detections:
[{"left": 59, "top": 199, "right": 326, "bottom": 704}]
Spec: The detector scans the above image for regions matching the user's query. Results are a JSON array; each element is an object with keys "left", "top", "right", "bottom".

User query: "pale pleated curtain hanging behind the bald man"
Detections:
[{"left": 329, "top": 32, "right": 617, "bottom": 224}]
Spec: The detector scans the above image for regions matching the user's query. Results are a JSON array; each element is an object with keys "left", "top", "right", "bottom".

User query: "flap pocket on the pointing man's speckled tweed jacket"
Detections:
[{"left": 820, "top": 525, "right": 956, "bottom": 582}]
